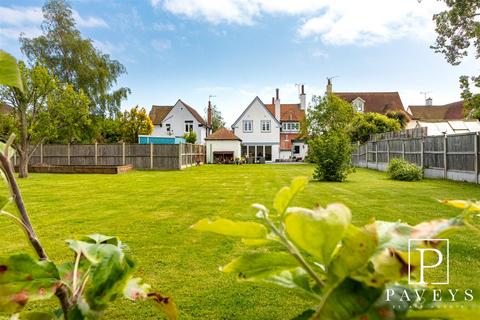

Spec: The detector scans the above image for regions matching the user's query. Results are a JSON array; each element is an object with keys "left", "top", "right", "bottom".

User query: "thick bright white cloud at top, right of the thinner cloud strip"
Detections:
[{"left": 299, "top": 0, "right": 442, "bottom": 45}]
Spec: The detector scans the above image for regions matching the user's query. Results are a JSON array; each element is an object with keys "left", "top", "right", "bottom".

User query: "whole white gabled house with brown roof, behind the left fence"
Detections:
[{"left": 150, "top": 99, "right": 210, "bottom": 144}]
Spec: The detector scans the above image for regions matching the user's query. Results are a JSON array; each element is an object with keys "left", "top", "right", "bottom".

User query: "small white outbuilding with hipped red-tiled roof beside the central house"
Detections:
[{"left": 205, "top": 128, "right": 242, "bottom": 163}]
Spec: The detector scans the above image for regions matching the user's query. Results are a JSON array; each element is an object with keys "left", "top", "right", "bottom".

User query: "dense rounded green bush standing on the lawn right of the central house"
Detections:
[{"left": 308, "top": 131, "right": 352, "bottom": 182}]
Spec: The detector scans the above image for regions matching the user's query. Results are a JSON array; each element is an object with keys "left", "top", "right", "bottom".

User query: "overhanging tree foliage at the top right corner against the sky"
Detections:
[{"left": 431, "top": 0, "right": 480, "bottom": 119}]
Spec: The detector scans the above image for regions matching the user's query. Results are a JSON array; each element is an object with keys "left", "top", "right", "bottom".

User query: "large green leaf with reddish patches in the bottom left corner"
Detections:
[{"left": 0, "top": 254, "right": 60, "bottom": 314}]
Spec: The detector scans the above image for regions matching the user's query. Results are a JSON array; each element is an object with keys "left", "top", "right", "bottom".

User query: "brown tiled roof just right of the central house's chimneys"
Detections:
[{"left": 333, "top": 92, "right": 405, "bottom": 114}]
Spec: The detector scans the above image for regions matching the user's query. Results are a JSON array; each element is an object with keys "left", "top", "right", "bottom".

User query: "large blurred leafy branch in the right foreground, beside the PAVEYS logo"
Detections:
[{"left": 192, "top": 177, "right": 480, "bottom": 320}]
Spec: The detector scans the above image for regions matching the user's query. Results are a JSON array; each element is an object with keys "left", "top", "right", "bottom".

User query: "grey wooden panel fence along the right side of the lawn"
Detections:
[{"left": 352, "top": 132, "right": 480, "bottom": 183}]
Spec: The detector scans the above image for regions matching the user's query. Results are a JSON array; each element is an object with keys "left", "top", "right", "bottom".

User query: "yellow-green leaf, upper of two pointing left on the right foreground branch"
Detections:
[{"left": 191, "top": 219, "right": 267, "bottom": 239}]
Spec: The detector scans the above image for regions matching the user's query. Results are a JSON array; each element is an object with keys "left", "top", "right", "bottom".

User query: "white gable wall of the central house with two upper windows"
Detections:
[{"left": 232, "top": 97, "right": 280, "bottom": 161}]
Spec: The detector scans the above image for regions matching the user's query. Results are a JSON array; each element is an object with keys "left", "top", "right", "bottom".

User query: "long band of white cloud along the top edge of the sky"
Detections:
[{"left": 155, "top": 0, "right": 443, "bottom": 45}]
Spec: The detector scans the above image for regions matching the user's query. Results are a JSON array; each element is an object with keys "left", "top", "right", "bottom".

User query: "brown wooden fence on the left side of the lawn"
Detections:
[{"left": 14, "top": 143, "right": 205, "bottom": 170}]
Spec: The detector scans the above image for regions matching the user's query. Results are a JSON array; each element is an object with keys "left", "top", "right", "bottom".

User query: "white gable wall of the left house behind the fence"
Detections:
[{"left": 152, "top": 100, "right": 207, "bottom": 144}]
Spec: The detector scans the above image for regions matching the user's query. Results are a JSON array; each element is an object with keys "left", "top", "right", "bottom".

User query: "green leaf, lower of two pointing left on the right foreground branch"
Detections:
[{"left": 221, "top": 252, "right": 298, "bottom": 281}]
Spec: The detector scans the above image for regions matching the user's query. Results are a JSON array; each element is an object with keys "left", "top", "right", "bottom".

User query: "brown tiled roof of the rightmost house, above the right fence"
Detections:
[{"left": 408, "top": 101, "right": 465, "bottom": 120}]
